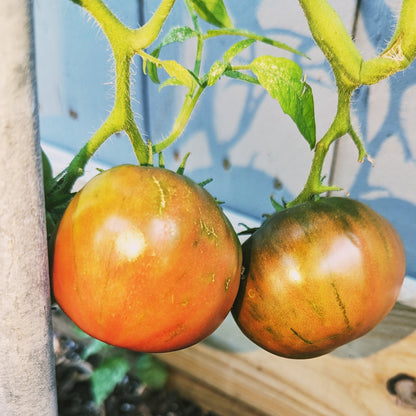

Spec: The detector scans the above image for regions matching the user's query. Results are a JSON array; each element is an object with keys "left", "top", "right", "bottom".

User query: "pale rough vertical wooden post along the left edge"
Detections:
[{"left": 0, "top": 0, "right": 57, "bottom": 416}]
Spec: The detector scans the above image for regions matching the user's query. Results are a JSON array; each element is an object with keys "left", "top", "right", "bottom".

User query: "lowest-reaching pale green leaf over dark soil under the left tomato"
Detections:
[{"left": 91, "top": 356, "right": 130, "bottom": 405}]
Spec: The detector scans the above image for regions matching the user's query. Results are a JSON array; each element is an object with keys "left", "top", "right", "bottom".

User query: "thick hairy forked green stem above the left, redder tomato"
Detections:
[{"left": 60, "top": 0, "right": 175, "bottom": 192}]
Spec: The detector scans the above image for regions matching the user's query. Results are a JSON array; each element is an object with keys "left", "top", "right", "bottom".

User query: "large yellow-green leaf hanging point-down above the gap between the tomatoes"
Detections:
[{"left": 250, "top": 56, "right": 316, "bottom": 149}]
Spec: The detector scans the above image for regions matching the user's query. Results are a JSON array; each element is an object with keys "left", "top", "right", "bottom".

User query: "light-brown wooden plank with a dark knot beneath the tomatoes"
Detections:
[{"left": 157, "top": 304, "right": 416, "bottom": 416}]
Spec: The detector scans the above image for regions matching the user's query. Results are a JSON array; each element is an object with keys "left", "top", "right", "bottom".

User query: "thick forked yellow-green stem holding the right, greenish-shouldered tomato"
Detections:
[{"left": 287, "top": 0, "right": 416, "bottom": 207}]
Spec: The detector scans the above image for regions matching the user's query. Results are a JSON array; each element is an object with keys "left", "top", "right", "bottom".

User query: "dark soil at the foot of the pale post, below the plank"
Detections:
[{"left": 54, "top": 336, "right": 218, "bottom": 416}]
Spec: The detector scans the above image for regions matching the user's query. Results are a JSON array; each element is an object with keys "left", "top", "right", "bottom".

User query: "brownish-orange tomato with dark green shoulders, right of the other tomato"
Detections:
[{"left": 232, "top": 197, "right": 405, "bottom": 358}]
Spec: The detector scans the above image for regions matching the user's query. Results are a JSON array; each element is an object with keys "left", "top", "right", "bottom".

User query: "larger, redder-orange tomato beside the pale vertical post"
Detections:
[{"left": 53, "top": 165, "right": 242, "bottom": 352}]
